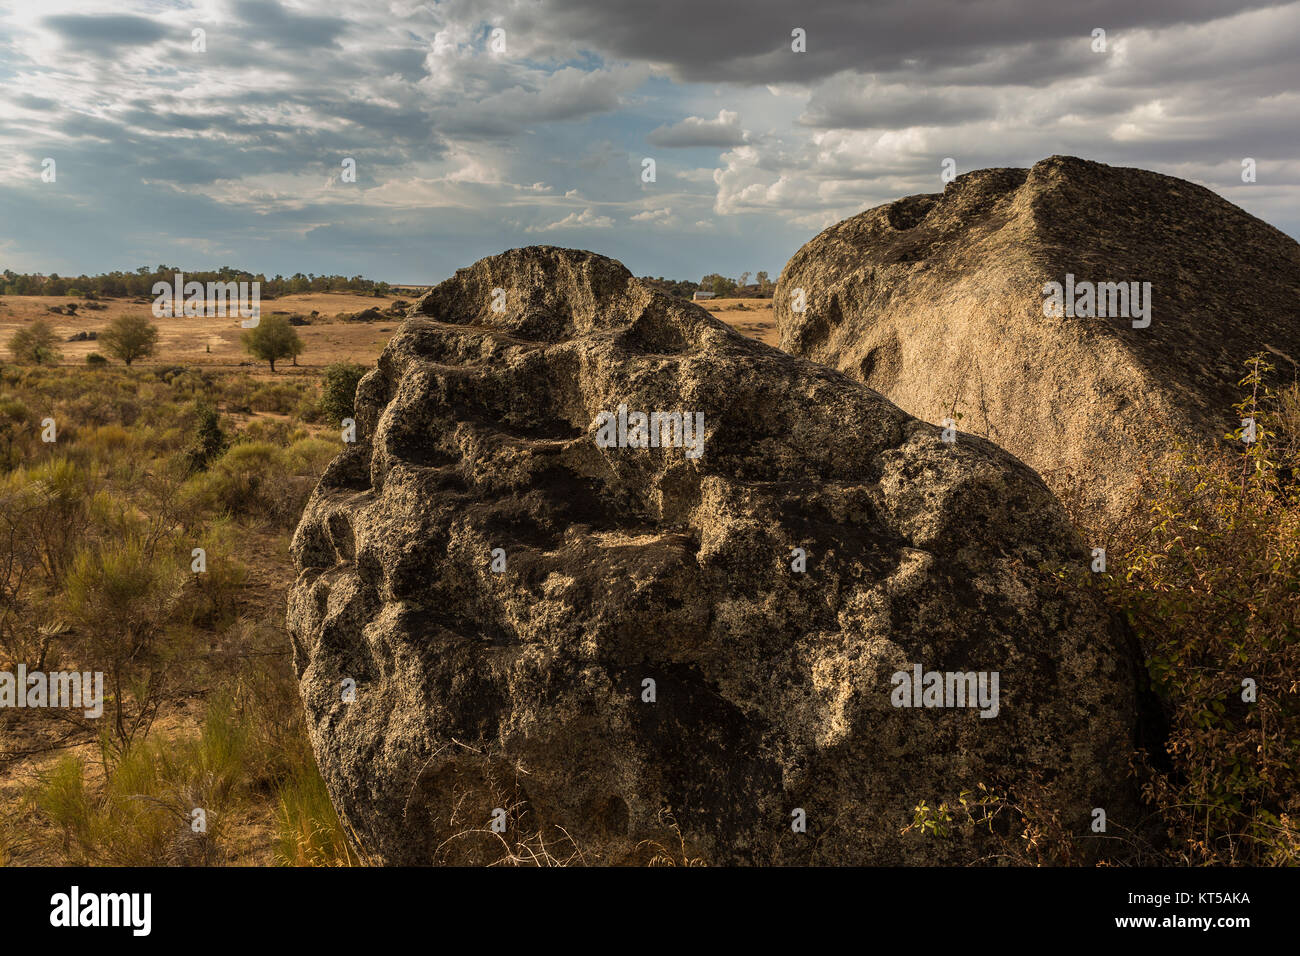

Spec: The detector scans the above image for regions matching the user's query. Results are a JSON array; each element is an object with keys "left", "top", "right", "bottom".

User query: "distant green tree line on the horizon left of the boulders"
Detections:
[{"left": 0, "top": 265, "right": 391, "bottom": 299}]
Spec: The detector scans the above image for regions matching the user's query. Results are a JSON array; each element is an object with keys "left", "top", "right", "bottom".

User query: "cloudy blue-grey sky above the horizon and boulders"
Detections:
[{"left": 0, "top": 0, "right": 1300, "bottom": 282}]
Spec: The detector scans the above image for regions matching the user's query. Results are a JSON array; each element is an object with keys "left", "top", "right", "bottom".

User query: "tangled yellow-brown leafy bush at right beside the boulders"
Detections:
[{"left": 1109, "top": 360, "right": 1300, "bottom": 865}]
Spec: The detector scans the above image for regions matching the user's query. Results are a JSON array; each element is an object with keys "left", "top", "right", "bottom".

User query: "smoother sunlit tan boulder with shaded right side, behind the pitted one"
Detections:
[{"left": 775, "top": 156, "right": 1300, "bottom": 520}]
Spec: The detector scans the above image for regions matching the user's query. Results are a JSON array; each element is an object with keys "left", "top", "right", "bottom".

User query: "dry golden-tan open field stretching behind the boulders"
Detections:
[{"left": 0, "top": 293, "right": 777, "bottom": 369}]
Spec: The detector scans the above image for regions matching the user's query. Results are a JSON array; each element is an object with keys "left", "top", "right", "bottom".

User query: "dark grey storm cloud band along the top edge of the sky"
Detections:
[{"left": 506, "top": 0, "right": 1279, "bottom": 83}]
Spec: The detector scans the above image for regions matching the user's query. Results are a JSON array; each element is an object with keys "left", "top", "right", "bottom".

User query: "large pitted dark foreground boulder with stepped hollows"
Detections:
[{"left": 289, "top": 247, "right": 1138, "bottom": 864}]
